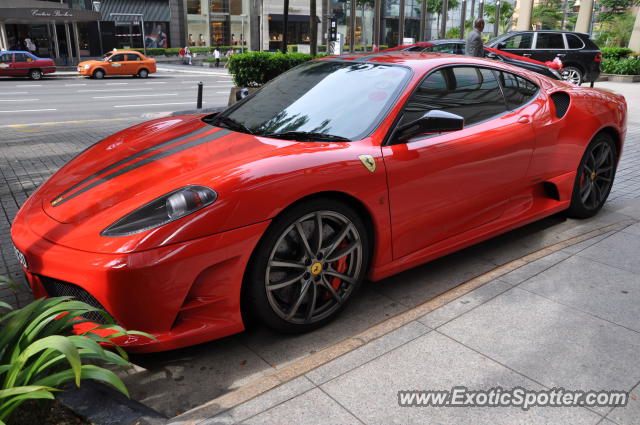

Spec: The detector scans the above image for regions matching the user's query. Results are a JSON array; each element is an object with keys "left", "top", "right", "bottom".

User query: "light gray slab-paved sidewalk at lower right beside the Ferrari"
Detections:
[{"left": 171, "top": 200, "right": 640, "bottom": 425}]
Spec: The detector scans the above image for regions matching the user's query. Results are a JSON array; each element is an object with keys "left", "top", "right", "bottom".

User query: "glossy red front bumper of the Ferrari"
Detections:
[{"left": 11, "top": 214, "right": 269, "bottom": 352}]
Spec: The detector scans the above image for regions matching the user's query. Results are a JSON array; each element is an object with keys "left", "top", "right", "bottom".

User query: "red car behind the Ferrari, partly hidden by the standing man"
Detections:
[{"left": 383, "top": 39, "right": 562, "bottom": 80}]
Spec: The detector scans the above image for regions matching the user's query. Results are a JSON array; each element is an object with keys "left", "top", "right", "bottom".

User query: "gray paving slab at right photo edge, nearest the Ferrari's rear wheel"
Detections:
[{"left": 578, "top": 232, "right": 640, "bottom": 273}]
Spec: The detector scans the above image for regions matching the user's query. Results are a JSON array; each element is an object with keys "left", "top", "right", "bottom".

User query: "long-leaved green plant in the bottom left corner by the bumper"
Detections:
[{"left": 0, "top": 278, "right": 152, "bottom": 425}]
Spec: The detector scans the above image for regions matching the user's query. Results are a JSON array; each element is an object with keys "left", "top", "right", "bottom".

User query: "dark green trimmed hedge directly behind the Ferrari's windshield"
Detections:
[{"left": 229, "top": 52, "right": 313, "bottom": 87}]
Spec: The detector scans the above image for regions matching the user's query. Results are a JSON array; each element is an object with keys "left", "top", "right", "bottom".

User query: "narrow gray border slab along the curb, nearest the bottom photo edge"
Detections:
[{"left": 195, "top": 376, "right": 315, "bottom": 425}]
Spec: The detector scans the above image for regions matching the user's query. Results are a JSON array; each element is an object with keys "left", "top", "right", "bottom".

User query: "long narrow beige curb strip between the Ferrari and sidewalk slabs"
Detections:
[{"left": 169, "top": 219, "right": 637, "bottom": 425}]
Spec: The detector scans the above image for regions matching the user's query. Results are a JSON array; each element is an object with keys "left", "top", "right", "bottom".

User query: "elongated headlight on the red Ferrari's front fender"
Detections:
[{"left": 101, "top": 186, "right": 218, "bottom": 236}]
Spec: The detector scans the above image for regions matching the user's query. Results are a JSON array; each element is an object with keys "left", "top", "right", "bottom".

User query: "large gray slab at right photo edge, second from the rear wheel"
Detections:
[{"left": 519, "top": 256, "right": 640, "bottom": 332}]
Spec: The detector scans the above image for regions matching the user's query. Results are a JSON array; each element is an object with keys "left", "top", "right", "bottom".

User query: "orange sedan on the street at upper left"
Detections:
[{"left": 78, "top": 50, "right": 156, "bottom": 79}]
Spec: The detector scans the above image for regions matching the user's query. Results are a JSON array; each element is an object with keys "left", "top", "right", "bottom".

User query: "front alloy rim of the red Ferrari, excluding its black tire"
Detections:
[{"left": 265, "top": 211, "right": 364, "bottom": 324}]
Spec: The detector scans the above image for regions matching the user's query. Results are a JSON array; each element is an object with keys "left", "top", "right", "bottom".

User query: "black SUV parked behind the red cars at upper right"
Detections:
[{"left": 486, "top": 31, "right": 602, "bottom": 84}]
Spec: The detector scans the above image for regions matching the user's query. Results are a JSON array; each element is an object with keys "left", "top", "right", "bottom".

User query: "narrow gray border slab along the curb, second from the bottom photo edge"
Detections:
[{"left": 306, "top": 322, "right": 430, "bottom": 385}]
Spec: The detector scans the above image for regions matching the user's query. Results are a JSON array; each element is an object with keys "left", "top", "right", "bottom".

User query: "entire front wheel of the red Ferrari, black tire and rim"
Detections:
[{"left": 243, "top": 198, "right": 371, "bottom": 333}]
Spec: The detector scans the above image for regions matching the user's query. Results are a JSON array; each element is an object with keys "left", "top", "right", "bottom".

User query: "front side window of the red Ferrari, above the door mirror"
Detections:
[{"left": 400, "top": 66, "right": 507, "bottom": 130}]
